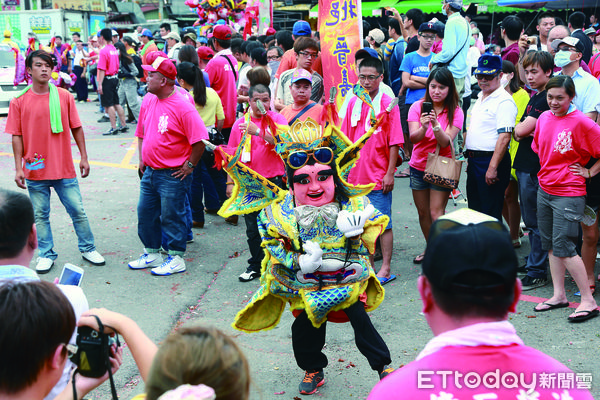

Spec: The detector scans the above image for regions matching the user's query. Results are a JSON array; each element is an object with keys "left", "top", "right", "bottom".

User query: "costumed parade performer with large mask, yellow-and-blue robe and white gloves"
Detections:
[{"left": 215, "top": 96, "right": 396, "bottom": 394}]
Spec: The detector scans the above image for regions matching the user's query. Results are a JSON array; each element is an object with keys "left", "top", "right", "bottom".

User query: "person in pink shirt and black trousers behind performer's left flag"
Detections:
[{"left": 227, "top": 84, "right": 287, "bottom": 282}]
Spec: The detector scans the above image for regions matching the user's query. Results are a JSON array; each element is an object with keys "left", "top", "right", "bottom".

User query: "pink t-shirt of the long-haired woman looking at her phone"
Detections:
[{"left": 408, "top": 100, "right": 464, "bottom": 171}]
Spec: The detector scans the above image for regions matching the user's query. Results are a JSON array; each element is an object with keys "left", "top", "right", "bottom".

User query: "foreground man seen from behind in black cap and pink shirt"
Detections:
[{"left": 368, "top": 209, "right": 593, "bottom": 400}]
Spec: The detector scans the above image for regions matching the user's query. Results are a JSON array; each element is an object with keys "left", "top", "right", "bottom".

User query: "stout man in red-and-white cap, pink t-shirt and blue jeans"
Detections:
[{"left": 128, "top": 53, "right": 208, "bottom": 276}]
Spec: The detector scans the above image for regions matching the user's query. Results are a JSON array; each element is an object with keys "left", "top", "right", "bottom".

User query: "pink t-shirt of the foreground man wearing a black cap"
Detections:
[{"left": 368, "top": 344, "right": 593, "bottom": 400}]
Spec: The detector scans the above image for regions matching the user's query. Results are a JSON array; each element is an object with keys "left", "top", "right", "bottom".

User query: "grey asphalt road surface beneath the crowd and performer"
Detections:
[{"left": 0, "top": 97, "right": 600, "bottom": 400}]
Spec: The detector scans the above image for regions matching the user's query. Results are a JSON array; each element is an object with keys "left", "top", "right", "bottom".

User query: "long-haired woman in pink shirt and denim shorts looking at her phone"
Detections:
[{"left": 408, "top": 68, "right": 464, "bottom": 264}]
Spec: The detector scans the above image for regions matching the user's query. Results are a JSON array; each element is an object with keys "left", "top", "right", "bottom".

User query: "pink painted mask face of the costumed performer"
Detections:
[{"left": 290, "top": 163, "right": 335, "bottom": 207}]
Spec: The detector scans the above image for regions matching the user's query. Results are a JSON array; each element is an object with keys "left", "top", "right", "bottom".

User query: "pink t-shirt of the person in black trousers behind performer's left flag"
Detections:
[{"left": 227, "top": 111, "right": 287, "bottom": 178}]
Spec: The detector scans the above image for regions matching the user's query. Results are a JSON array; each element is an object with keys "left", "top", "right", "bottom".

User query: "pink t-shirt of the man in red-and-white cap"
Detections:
[{"left": 135, "top": 90, "right": 208, "bottom": 169}]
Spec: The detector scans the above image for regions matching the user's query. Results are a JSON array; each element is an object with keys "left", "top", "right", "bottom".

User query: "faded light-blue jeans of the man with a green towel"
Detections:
[{"left": 27, "top": 178, "right": 96, "bottom": 260}]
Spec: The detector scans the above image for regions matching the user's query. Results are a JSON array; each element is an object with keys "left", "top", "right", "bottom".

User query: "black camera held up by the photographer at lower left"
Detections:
[{"left": 71, "top": 326, "right": 114, "bottom": 378}]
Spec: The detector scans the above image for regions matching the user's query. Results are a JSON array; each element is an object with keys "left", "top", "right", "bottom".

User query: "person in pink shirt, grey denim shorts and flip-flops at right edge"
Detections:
[{"left": 531, "top": 75, "right": 600, "bottom": 322}]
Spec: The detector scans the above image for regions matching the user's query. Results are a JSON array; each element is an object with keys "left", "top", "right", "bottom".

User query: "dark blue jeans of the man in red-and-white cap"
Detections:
[{"left": 138, "top": 167, "right": 192, "bottom": 256}]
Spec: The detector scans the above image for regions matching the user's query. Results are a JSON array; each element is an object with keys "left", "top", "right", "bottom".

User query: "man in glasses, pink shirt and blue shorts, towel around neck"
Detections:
[{"left": 342, "top": 57, "right": 404, "bottom": 285}]
